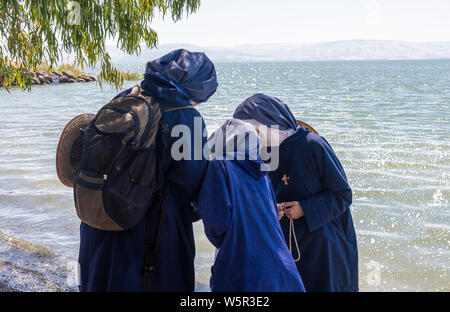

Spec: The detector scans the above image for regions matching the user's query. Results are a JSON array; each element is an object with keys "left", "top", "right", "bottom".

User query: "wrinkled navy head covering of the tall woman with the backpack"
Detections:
[{"left": 141, "top": 49, "right": 218, "bottom": 107}]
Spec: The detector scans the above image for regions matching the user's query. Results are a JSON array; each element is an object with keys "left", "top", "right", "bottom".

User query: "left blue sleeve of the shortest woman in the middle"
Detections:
[{"left": 197, "top": 160, "right": 231, "bottom": 248}]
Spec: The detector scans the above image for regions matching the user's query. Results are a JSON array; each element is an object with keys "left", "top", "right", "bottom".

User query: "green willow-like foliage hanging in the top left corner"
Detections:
[{"left": 0, "top": 0, "right": 200, "bottom": 89}]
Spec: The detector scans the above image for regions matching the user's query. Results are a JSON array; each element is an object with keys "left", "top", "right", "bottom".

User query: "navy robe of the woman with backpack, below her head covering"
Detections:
[{"left": 79, "top": 109, "right": 207, "bottom": 292}]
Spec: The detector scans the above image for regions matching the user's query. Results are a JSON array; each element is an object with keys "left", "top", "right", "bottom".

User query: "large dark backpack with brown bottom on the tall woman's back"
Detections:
[{"left": 73, "top": 85, "right": 166, "bottom": 231}]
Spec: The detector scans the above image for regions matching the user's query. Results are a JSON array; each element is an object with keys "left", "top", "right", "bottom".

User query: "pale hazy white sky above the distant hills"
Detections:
[{"left": 153, "top": 0, "right": 450, "bottom": 46}]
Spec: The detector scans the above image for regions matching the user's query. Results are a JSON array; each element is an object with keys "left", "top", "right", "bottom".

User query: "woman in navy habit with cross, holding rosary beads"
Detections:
[{"left": 233, "top": 94, "right": 358, "bottom": 292}]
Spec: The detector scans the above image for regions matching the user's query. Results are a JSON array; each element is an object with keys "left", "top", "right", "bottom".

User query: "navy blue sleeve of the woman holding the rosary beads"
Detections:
[{"left": 300, "top": 136, "right": 352, "bottom": 232}]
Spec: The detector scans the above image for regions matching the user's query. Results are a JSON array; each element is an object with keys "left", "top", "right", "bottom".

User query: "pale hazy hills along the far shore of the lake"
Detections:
[{"left": 103, "top": 40, "right": 450, "bottom": 68}]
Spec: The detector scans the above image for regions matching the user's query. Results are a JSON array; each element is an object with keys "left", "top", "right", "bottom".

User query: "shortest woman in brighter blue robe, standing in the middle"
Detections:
[{"left": 198, "top": 120, "right": 304, "bottom": 292}]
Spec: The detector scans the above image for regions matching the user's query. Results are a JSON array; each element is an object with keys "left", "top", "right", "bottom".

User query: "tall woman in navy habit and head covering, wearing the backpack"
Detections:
[{"left": 79, "top": 50, "right": 217, "bottom": 292}]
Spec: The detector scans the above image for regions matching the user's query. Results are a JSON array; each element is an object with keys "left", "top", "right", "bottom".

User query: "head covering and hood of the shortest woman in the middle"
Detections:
[{"left": 208, "top": 119, "right": 268, "bottom": 179}]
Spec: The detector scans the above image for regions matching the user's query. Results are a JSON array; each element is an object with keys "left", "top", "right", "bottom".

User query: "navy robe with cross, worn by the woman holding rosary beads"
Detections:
[{"left": 270, "top": 128, "right": 358, "bottom": 292}]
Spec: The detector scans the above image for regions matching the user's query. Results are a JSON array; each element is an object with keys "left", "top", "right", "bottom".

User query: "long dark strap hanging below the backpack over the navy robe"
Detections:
[{"left": 142, "top": 183, "right": 169, "bottom": 292}]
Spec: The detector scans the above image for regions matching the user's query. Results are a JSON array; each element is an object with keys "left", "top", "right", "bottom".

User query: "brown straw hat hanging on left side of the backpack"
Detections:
[{"left": 56, "top": 114, "right": 95, "bottom": 187}]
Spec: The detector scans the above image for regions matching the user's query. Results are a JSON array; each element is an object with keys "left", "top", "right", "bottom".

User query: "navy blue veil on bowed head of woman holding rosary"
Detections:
[{"left": 233, "top": 93, "right": 297, "bottom": 131}]
